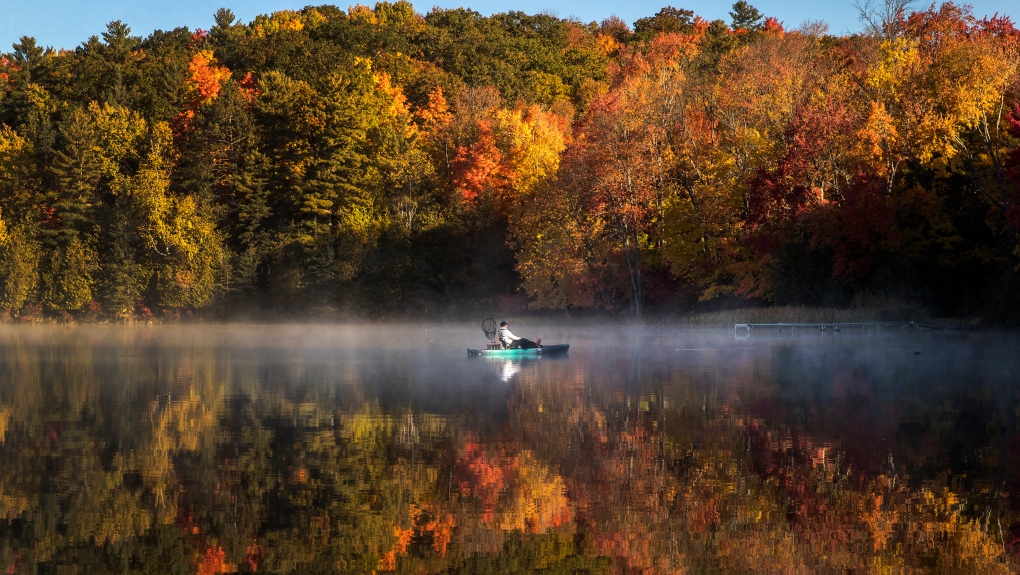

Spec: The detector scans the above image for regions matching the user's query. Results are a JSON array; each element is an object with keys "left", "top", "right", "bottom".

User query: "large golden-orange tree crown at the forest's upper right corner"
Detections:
[{"left": 860, "top": 3, "right": 1017, "bottom": 196}]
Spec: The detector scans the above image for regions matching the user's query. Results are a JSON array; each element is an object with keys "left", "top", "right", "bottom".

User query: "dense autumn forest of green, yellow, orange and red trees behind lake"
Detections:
[{"left": 0, "top": 0, "right": 1020, "bottom": 323}]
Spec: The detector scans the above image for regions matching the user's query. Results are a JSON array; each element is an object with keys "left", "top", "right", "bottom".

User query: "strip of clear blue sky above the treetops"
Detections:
[{"left": 0, "top": 0, "right": 1020, "bottom": 53}]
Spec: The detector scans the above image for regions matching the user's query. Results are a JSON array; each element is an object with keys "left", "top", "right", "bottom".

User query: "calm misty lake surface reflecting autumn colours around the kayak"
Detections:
[{"left": 0, "top": 323, "right": 1020, "bottom": 574}]
